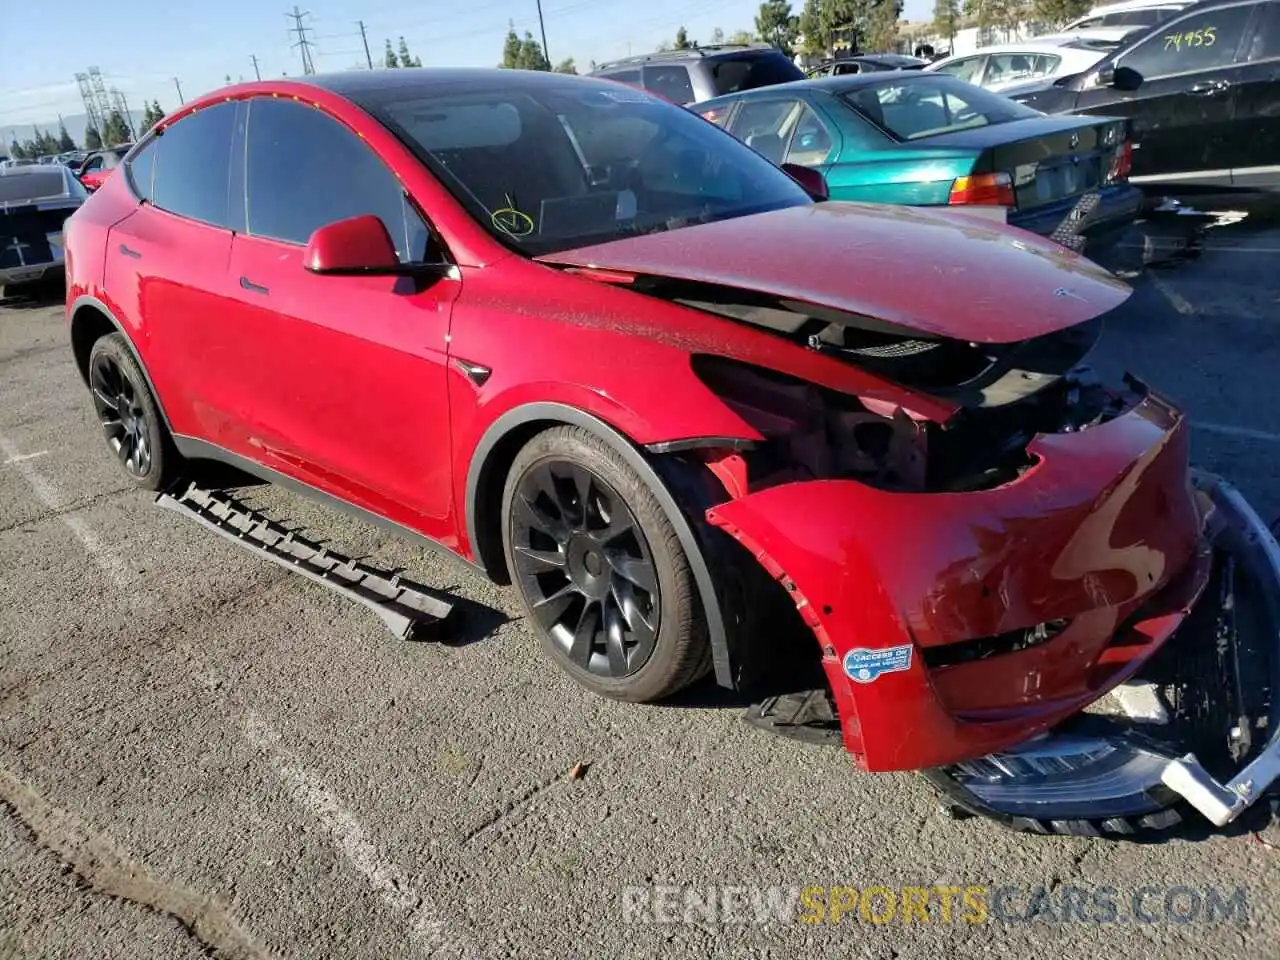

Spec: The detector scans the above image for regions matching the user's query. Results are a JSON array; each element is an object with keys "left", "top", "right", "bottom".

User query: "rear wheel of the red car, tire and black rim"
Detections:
[{"left": 88, "top": 333, "right": 179, "bottom": 490}]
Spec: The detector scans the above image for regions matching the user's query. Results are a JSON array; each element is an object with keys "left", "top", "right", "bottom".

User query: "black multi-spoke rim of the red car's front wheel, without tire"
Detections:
[{"left": 509, "top": 460, "right": 662, "bottom": 680}]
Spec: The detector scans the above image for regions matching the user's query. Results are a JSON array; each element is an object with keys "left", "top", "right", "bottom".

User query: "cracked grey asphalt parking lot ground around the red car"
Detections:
[{"left": 0, "top": 209, "right": 1280, "bottom": 960}]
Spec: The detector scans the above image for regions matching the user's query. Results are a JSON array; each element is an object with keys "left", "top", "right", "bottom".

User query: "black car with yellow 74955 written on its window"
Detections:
[{"left": 1010, "top": 0, "right": 1280, "bottom": 193}]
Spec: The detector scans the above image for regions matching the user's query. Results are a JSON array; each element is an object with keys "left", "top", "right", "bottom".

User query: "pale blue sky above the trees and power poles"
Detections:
[{"left": 0, "top": 0, "right": 932, "bottom": 127}]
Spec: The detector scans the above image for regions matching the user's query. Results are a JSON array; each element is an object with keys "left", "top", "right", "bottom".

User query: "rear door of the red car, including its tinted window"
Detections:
[{"left": 104, "top": 104, "right": 243, "bottom": 439}]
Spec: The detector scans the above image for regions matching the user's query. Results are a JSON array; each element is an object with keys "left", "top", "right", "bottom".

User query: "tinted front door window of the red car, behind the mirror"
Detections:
[{"left": 244, "top": 97, "right": 429, "bottom": 262}]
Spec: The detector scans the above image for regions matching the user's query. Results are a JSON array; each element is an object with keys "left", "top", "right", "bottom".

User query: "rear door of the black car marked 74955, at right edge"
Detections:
[{"left": 1231, "top": 0, "right": 1280, "bottom": 188}]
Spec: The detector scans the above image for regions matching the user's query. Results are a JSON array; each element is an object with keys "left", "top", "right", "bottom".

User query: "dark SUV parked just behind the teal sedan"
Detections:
[{"left": 590, "top": 44, "right": 804, "bottom": 106}]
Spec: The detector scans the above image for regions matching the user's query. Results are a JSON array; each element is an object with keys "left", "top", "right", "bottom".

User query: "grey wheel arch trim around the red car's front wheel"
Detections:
[{"left": 465, "top": 402, "right": 733, "bottom": 687}]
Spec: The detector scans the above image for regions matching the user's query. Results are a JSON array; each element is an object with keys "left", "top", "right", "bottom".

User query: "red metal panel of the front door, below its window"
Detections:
[{"left": 217, "top": 236, "right": 461, "bottom": 547}]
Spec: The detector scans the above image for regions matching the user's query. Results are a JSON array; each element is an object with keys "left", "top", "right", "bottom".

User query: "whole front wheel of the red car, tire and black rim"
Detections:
[{"left": 502, "top": 426, "right": 710, "bottom": 703}]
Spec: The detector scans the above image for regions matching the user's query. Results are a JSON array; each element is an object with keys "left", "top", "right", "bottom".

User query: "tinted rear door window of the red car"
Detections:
[{"left": 151, "top": 104, "right": 237, "bottom": 227}]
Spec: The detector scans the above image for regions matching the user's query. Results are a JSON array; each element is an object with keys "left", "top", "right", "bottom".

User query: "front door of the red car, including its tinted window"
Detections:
[{"left": 221, "top": 97, "right": 461, "bottom": 540}]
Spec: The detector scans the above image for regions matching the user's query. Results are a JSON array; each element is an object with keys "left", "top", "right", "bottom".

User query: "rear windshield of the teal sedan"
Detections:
[{"left": 844, "top": 74, "right": 1041, "bottom": 140}]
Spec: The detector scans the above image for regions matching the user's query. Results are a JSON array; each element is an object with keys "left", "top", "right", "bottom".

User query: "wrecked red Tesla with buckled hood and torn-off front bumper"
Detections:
[{"left": 67, "top": 70, "right": 1280, "bottom": 833}]
